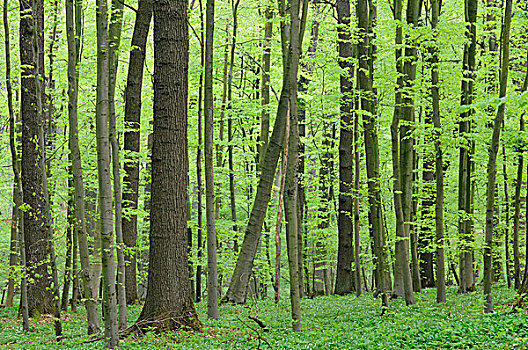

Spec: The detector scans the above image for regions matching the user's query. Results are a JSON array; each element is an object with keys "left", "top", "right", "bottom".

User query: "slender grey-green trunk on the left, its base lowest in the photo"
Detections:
[{"left": 96, "top": 0, "right": 119, "bottom": 348}]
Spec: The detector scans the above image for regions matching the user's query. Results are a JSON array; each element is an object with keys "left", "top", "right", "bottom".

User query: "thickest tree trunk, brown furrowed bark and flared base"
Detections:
[{"left": 136, "top": 0, "right": 201, "bottom": 331}]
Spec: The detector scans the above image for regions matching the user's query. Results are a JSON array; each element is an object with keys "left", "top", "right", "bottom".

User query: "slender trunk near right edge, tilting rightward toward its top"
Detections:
[{"left": 484, "top": 0, "right": 513, "bottom": 313}]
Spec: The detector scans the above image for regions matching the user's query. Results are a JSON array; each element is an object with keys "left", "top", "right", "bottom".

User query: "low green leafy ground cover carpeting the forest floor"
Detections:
[{"left": 0, "top": 285, "right": 528, "bottom": 350}]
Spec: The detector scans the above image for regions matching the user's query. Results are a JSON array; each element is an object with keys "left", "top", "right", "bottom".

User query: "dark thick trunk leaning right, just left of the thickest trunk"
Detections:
[{"left": 122, "top": 0, "right": 152, "bottom": 304}]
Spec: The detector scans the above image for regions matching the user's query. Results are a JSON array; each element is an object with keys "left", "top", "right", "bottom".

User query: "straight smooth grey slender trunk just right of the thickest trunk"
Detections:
[{"left": 204, "top": 0, "right": 220, "bottom": 320}]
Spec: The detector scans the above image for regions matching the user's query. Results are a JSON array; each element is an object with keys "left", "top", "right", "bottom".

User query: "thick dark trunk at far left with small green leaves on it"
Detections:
[{"left": 19, "top": 0, "right": 53, "bottom": 317}]
